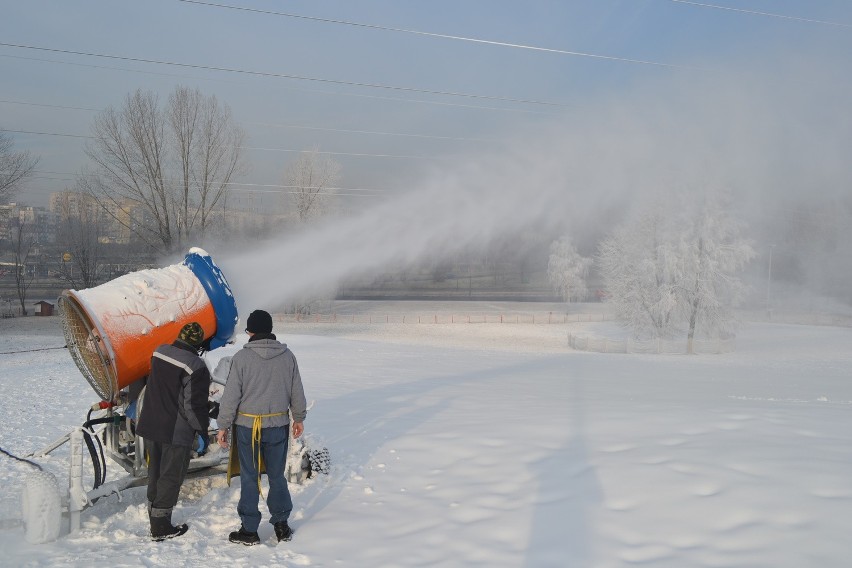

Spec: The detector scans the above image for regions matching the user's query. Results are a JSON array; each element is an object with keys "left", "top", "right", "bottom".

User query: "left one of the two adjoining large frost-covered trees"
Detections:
[{"left": 598, "top": 210, "right": 679, "bottom": 338}]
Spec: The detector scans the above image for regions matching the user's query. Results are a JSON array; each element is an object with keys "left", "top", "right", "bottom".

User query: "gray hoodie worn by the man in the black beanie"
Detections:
[{"left": 216, "top": 336, "right": 307, "bottom": 430}]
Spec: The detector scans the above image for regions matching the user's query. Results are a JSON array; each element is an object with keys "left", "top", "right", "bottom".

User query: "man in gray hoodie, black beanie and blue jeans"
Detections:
[{"left": 216, "top": 310, "right": 307, "bottom": 546}]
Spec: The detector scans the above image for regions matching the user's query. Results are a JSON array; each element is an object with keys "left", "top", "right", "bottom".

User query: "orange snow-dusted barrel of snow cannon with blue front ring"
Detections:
[{"left": 58, "top": 248, "right": 238, "bottom": 400}]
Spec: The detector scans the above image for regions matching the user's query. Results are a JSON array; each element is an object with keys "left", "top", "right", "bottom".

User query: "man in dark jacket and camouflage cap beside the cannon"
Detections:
[{"left": 136, "top": 322, "right": 210, "bottom": 541}]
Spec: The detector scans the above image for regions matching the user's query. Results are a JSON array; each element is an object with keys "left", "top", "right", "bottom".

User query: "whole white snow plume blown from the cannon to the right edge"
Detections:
[{"left": 218, "top": 52, "right": 850, "bottom": 312}]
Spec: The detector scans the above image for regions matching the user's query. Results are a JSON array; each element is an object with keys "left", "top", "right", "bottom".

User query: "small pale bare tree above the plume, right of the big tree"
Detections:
[{"left": 284, "top": 146, "right": 340, "bottom": 223}]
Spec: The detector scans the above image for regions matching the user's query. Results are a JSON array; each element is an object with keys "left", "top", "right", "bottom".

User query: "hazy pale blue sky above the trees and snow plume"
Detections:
[{"left": 6, "top": 0, "right": 852, "bottom": 211}]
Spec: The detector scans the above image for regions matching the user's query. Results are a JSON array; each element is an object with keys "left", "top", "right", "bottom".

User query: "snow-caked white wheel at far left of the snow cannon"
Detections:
[{"left": 21, "top": 471, "right": 62, "bottom": 544}]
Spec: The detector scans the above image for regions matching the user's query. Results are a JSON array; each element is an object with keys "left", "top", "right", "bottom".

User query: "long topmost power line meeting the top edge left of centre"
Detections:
[{"left": 177, "top": 0, "right": 697, "bottom": 69}]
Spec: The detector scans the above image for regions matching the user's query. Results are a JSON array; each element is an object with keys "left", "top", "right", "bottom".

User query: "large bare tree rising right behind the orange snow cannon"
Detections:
[{"left": 79, "top": 87, "right": 244, "bottom": 252}]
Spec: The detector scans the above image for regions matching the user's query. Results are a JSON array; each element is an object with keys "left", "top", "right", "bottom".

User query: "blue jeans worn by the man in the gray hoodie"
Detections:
[{"left": 232, "top": 426, "right": 293, "bottom": 532}]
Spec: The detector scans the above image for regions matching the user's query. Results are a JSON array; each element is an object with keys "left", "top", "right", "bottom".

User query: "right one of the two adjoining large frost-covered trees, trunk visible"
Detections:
[{"left": 678, "top": 192, "right": 755, "bottom": 353}]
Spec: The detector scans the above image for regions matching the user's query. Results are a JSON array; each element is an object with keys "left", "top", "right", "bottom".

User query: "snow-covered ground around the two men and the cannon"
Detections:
[{"left": 0, "top": 305, "right": 852, "bottom": 568}]
